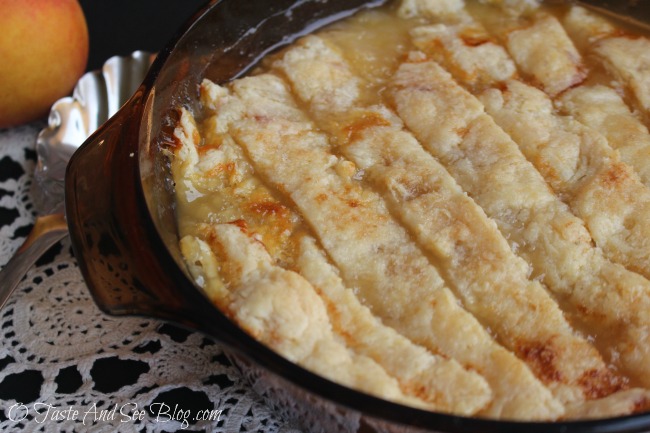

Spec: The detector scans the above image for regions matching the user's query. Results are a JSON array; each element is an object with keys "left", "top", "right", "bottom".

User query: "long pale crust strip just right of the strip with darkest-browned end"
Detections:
[{"left": 390, "top": 56, "right": 650, "bottom": 386}]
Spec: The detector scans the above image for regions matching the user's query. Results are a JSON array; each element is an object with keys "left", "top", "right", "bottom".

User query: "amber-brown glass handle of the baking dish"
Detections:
[{"left": 65, "top": 89, "right": 245, "bottom": 348}]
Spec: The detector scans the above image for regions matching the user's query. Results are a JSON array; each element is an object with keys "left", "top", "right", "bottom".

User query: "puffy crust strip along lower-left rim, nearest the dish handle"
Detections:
[{"left": 181, "top": 224, "right": 436, "bottom": 409}]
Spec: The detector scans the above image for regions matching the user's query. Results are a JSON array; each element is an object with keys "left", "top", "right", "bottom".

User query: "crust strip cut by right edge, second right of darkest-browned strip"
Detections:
[{"left": 480, "top": 80, "right": 650, "bottom": 277}]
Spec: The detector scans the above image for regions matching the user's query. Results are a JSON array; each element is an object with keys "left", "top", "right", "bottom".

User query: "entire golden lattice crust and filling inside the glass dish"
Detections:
[{"left": 168, "top": 0, "right": 650, "bottom": 420}]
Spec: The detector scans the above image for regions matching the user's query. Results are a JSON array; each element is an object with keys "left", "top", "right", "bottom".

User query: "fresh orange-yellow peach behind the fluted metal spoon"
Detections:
[{"left": 0, "top": 0, "right": 88, "bottom": 127}]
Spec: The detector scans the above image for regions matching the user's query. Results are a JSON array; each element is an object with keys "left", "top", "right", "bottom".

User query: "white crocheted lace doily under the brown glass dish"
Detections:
[{"left": 0, "top": 122, "right": 298, "bottom": 433}]
